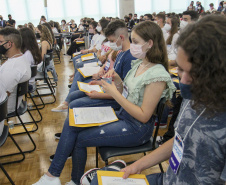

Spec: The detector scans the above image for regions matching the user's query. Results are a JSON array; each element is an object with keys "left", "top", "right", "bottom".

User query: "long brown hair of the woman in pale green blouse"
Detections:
[{"left": 133, "top": 21, "right": 169, "bottom": 71}]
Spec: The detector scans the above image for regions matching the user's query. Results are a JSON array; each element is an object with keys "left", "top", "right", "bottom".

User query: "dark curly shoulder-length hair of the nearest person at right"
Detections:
[{"left": 177, "top": 15, "right": 226, "bottom": 114}]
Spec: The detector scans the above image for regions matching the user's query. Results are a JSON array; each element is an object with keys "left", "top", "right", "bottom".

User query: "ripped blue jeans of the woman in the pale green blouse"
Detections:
[{"left": 49, "top": 108, "right": 155, "bottom": 184}]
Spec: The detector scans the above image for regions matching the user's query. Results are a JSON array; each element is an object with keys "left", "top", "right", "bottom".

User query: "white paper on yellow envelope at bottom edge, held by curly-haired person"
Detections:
[{"left": 101, "top": 176, "right": 147, "bottom": 185}]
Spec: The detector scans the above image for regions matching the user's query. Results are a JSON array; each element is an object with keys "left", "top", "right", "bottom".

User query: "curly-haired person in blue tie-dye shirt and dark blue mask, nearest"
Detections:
[{"left": 86, "top": 16, "right": 226, "bottom": 185}]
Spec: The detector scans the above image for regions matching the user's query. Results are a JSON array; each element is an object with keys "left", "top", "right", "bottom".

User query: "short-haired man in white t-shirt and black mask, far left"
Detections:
[{"left": 0, "top": 28, "right": 31, "bottom": 113}]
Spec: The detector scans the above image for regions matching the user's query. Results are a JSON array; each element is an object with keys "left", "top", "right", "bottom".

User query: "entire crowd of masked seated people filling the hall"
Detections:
[{"left": 0, "top": 1, "right": 226, "bottom": 185}]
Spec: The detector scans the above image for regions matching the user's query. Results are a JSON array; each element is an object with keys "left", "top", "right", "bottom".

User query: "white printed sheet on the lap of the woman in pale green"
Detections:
[{"left": 73, "top": 107, "right": 117, "bottom": 124}]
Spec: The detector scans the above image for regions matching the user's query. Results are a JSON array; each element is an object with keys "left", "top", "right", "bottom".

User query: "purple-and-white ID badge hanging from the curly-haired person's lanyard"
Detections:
[{"left": 169, "top": 132, "right": 184, "bottom": 174}]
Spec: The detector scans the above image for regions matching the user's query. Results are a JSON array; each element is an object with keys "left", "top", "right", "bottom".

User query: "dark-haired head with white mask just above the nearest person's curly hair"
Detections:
[{"left": 180, "top": 11, "right": 198, "bottom": 32}]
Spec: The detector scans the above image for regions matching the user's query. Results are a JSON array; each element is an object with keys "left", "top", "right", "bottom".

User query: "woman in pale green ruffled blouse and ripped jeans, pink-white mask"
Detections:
[{"left": 34, "top": 21, "right": 175, "bottom": 185}]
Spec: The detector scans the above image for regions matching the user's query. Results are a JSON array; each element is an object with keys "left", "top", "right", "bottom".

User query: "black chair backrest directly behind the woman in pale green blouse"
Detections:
[{"left": 153, "top": 98, "right": 166, "bottom": 149}]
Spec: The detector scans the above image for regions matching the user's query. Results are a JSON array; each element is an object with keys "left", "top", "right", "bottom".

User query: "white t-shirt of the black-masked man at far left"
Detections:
[{"left": 0, "top": 55, "right": 31, "bottom": 113}]
